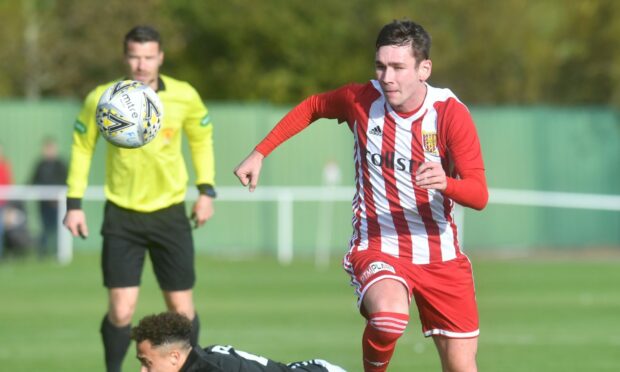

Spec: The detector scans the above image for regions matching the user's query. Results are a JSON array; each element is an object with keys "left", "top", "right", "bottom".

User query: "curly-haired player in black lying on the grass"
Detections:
[{"left": 131, "top": 312, "right": 345, "bottom": 372}]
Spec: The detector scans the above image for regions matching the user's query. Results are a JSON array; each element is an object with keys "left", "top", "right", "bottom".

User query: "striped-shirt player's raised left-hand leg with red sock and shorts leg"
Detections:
[{"left": 344, "top": 251, "right": 410, "bottom": 371}]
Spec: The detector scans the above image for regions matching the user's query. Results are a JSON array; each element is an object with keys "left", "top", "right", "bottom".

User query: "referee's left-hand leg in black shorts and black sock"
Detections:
[{"left": 101, "top": 203, "right": 146, "bottom": 371}]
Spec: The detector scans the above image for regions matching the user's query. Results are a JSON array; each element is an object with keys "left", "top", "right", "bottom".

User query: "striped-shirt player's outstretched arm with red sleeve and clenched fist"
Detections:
[{"left": 233, "top": 86, "right": 351, "bottom": 192}]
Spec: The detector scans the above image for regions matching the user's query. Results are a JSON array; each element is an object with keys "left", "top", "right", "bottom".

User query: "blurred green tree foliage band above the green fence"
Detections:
[{"left": 0, "top": 0, "right": 620, "bottom": 106}]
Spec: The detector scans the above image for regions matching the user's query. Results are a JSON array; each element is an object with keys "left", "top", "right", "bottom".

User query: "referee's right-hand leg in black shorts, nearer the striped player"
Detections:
[{"left": 148, "top": 204, "right": 200, "bottom": 345}]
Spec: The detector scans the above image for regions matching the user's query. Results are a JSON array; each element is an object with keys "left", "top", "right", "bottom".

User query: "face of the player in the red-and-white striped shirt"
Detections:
[{"left": 375, "top": 45, "right": 432, "bottom": 112}]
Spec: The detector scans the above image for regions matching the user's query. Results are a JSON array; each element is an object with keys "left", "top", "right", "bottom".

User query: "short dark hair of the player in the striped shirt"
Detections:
[{"left": 376, "top": 20, "right": 431, "bottom": 63}]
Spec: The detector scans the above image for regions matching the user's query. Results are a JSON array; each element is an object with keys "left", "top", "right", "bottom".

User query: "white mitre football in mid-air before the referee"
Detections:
[{"left": 96, "top": 80, "right": 164, "bottom": 148}]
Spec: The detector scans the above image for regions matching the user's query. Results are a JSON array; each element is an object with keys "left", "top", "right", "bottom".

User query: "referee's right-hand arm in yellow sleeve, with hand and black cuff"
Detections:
[{"left": 183, "top": 88, "right": 216, "bottom": 227}]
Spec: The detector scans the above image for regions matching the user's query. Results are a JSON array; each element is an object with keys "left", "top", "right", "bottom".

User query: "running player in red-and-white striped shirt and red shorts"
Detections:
[{"left": 235, "top": 21, "right": 488, "bottom": 371}]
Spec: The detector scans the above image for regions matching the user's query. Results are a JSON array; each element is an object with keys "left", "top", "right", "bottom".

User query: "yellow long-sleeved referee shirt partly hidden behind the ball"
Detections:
[{"left": 67, "top": 75, "right": 215, "bottom": 212}]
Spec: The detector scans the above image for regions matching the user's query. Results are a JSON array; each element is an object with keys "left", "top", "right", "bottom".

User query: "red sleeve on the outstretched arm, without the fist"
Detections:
[{"left": 255, "top": 85, "right": 351, "bottom": 157}]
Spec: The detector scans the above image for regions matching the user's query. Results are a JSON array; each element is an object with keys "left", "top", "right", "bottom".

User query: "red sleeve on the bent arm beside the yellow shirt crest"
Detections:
[{"left": 443, "top": 99, "right": 489, "bottom": 210}]
